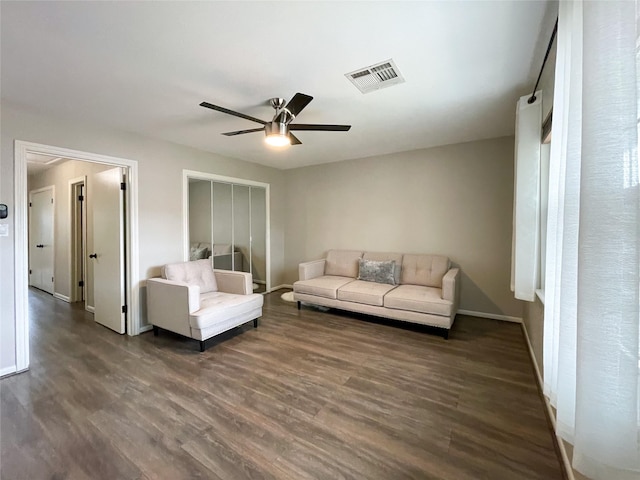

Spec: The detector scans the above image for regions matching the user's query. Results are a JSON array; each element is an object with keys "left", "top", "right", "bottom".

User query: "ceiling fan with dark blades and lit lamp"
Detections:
[{"left": 200, "top": 93, "right": 351, "bottom": 147}]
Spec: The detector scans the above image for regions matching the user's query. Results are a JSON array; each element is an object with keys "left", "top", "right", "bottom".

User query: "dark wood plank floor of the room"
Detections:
[{"left": 0, "top": 291, "right": 562, "bottom": 480}]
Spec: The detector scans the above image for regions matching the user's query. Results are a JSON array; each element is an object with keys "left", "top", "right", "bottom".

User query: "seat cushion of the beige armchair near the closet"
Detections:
[{"left": 189, "top": 292, "right": 264, "bottom": 330}]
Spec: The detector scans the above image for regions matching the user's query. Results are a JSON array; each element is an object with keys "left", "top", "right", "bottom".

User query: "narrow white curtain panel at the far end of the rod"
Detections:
[{"left": 511, "top": 91, "right": 542, "bottom": 302}]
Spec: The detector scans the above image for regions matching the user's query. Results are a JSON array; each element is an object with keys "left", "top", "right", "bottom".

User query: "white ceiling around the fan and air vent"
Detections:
[{"left": 0, "top": 1, "right": 553, "bottom": 168}]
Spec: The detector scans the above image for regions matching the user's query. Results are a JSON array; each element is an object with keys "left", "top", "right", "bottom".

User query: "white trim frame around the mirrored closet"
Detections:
[{"left": 182, "top": 170, "right": 271, "bottom": 292}]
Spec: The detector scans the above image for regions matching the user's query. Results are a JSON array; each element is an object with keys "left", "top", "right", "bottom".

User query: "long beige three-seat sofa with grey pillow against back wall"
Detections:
[{"left": 293, "top": 250, "right": 460, "bottom": 338}]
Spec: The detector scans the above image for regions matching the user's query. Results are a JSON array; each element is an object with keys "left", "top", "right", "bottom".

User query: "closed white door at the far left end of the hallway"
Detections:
[{"left": 29, "top": 187, "right": 54, "bottom": 295}]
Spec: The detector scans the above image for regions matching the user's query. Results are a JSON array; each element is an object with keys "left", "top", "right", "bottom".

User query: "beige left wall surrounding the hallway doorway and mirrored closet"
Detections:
[{"left": 0, "top": 102, "right": 285, "bottom": 372}]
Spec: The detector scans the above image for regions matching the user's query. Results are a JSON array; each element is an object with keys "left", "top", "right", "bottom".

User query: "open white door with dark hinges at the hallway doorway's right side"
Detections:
[{"left": 87, "top": 167, "right": 125, "bottom": 333}]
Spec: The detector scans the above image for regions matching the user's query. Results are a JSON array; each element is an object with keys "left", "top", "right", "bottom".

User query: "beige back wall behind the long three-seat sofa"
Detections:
[{"left": 285, "top": 137, "right": 522, "bottom": 318}]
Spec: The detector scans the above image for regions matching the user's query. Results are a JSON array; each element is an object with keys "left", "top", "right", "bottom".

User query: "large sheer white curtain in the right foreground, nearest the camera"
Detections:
[{"left": 544, "top": 1, "right": 640, "bottom": 480}]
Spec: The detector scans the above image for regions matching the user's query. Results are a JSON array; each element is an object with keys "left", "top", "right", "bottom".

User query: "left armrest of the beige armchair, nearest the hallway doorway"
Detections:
[{"left": 147, "top": 278, "right": 200, "bottom": 337}]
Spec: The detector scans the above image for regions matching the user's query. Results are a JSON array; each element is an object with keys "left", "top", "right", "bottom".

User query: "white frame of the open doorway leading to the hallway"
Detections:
[{"left": 14, "top": 140, "right": 140, "bottom": 371}]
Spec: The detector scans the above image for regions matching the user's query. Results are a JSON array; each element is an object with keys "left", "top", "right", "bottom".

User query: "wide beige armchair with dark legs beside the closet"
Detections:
[{"left": 147, "top": 259, "right": 264, "bottom": 352}]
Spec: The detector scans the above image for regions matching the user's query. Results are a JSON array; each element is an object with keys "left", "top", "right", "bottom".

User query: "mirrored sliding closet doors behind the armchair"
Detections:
[{"left": 184, "top": 172, "right": 270, "bottom": 292}]
